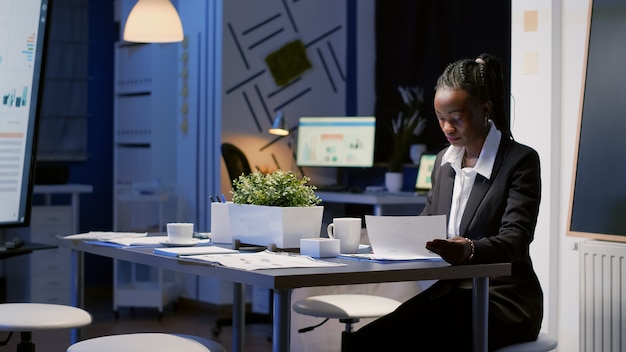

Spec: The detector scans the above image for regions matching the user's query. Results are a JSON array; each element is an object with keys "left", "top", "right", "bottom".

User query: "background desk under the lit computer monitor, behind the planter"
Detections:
[{"left": 315, "top": 192, "right": 426, "bottom": 215}]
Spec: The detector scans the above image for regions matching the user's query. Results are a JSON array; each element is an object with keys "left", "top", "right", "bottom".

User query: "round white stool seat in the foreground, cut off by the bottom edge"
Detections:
[{"left": 66, "top": 333, "right": 226, "bottom": 352}]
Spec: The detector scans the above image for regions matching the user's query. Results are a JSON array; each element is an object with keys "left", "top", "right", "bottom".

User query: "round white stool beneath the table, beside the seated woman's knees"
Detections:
[{"left": 293, "top": 294, "right": 401, "bottom": 350}]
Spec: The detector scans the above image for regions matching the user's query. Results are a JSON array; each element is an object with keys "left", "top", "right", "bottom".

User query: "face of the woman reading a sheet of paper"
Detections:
[{"left": 434, "top": 88, "right": 491, "bottom": 153}]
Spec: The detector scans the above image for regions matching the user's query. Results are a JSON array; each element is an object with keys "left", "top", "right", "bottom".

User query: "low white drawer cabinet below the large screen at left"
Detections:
[{"left": 6, "top": 185, "right": 92, "bottom": 304}]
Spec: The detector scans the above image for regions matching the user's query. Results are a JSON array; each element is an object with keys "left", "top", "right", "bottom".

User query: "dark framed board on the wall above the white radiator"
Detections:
[{"left": 567, "top": 0, "right": 626, "bottom": 242}]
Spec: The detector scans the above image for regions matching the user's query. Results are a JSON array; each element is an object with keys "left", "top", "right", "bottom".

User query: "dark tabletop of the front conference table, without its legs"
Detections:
[{"left": 59, "top": 240, "right": 511, "bottom": 290}]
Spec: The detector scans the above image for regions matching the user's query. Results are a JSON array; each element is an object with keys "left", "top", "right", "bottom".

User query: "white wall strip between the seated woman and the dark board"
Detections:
[{"left": 511, "top": 0, "right": 589, "bottom": 352}]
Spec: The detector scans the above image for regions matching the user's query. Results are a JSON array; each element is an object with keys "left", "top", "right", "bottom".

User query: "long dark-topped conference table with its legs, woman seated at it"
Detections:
[{"left": 58, "top": 239, "right": 511, "bottom": 352}]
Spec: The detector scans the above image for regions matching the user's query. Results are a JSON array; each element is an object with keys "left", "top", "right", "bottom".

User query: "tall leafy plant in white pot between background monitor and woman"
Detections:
[{"left": 385, "top": 86, "right": 426, "bottom": 192}]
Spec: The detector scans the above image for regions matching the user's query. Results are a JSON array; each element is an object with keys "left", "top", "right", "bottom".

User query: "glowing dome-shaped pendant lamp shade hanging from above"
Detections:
[{"left": 124, "top": 0, "right": 183, "bottom": 43}]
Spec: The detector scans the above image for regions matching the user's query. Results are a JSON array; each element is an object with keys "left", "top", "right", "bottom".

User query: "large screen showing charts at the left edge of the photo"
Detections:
[{"left": 0, "top": 0, "right": 49, "bottom": 227}]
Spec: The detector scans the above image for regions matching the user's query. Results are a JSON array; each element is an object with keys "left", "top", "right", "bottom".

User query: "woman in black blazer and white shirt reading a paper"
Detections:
[{"left": 346, "top": 54, "right": 543, "bottom": 351}]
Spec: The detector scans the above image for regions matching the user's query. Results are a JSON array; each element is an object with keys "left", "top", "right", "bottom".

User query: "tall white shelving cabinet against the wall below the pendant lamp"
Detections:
[{"left": 113, "top": 43, "right": 180, "bottom": 316}]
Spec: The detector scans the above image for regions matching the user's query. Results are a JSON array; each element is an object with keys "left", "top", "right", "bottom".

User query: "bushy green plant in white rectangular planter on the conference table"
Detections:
[{"left": 228, "top": 170, "right": 324, "bottom": 248}]
